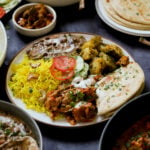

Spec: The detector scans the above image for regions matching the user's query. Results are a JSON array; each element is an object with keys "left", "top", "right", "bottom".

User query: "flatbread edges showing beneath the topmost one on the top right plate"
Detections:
[{"left": 103, "top": 0, "right": 150, "bottom": 30}]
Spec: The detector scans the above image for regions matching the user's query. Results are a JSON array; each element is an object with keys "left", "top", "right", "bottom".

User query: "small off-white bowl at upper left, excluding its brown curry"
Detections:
[{"left": 12, "top": 3, "right": 57, "bottom": 37}]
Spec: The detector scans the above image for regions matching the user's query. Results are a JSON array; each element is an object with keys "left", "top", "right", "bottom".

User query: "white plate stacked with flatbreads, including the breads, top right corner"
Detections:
[{"left": 95, "top": 0, "right": 150, "bottom": 37}]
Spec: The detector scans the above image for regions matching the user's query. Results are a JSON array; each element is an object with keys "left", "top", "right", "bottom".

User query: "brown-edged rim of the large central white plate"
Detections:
[{"left": 5, "top": 32, "right": 143, "bottom": 128}]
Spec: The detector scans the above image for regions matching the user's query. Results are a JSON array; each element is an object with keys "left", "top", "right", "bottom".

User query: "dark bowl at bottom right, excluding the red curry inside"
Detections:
[{"left": 99, "top": 92, "right": 150, "bottom": 150}]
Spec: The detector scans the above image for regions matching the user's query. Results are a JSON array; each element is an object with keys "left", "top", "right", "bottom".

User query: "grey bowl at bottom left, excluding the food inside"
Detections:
[{"left": 0, "top": 100, "right": 43, "bottom": 150}]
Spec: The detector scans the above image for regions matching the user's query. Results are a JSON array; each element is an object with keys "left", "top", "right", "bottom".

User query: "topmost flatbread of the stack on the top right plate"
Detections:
[{"left": 110, "top": 0, "right": 150, "bottom": 25}]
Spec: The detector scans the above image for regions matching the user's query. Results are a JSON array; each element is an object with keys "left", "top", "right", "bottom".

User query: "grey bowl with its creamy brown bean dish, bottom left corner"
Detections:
[{"left": 0, "top": 100, "right": 42, "bottom": 150}]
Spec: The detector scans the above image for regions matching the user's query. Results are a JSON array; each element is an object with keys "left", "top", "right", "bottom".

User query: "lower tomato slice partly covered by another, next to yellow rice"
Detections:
[{"left": 50, "top": 65, "right": 74, "bottom": 80}]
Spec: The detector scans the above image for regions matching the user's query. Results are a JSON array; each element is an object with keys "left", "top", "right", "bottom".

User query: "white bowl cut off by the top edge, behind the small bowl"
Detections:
[{"left": 26, "top": 0, "right": 80, "bottom": 7}]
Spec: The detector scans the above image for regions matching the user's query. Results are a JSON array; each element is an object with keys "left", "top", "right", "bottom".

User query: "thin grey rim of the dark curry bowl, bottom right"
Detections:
[{"left": 98, "top": 91, "right": 150, "bottom": 150}]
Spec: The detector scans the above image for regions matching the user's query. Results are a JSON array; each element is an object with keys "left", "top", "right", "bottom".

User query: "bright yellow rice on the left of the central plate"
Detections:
[{"left": 9, "top": 55, "right": 60, "bottom": 113}]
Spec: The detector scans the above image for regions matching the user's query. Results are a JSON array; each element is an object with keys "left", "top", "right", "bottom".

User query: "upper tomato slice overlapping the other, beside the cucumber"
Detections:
[{"left": 53, "top": 56, "right": 76, "bottom": 72}]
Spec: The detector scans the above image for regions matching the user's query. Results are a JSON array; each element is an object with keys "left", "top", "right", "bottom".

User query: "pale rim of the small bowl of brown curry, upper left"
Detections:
[{"left": 12, "top": 3, "right": 57, "bottom": 32}]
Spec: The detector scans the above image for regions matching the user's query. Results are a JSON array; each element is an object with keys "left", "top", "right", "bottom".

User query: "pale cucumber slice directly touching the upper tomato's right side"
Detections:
[{"left": 75, "top": 56, "right": 84, "bottom": 72}]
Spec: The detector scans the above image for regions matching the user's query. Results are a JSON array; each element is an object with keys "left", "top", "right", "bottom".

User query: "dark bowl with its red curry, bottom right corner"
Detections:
[{"left": 99, "top": 92, "right": 150, "bottom": 150}]
